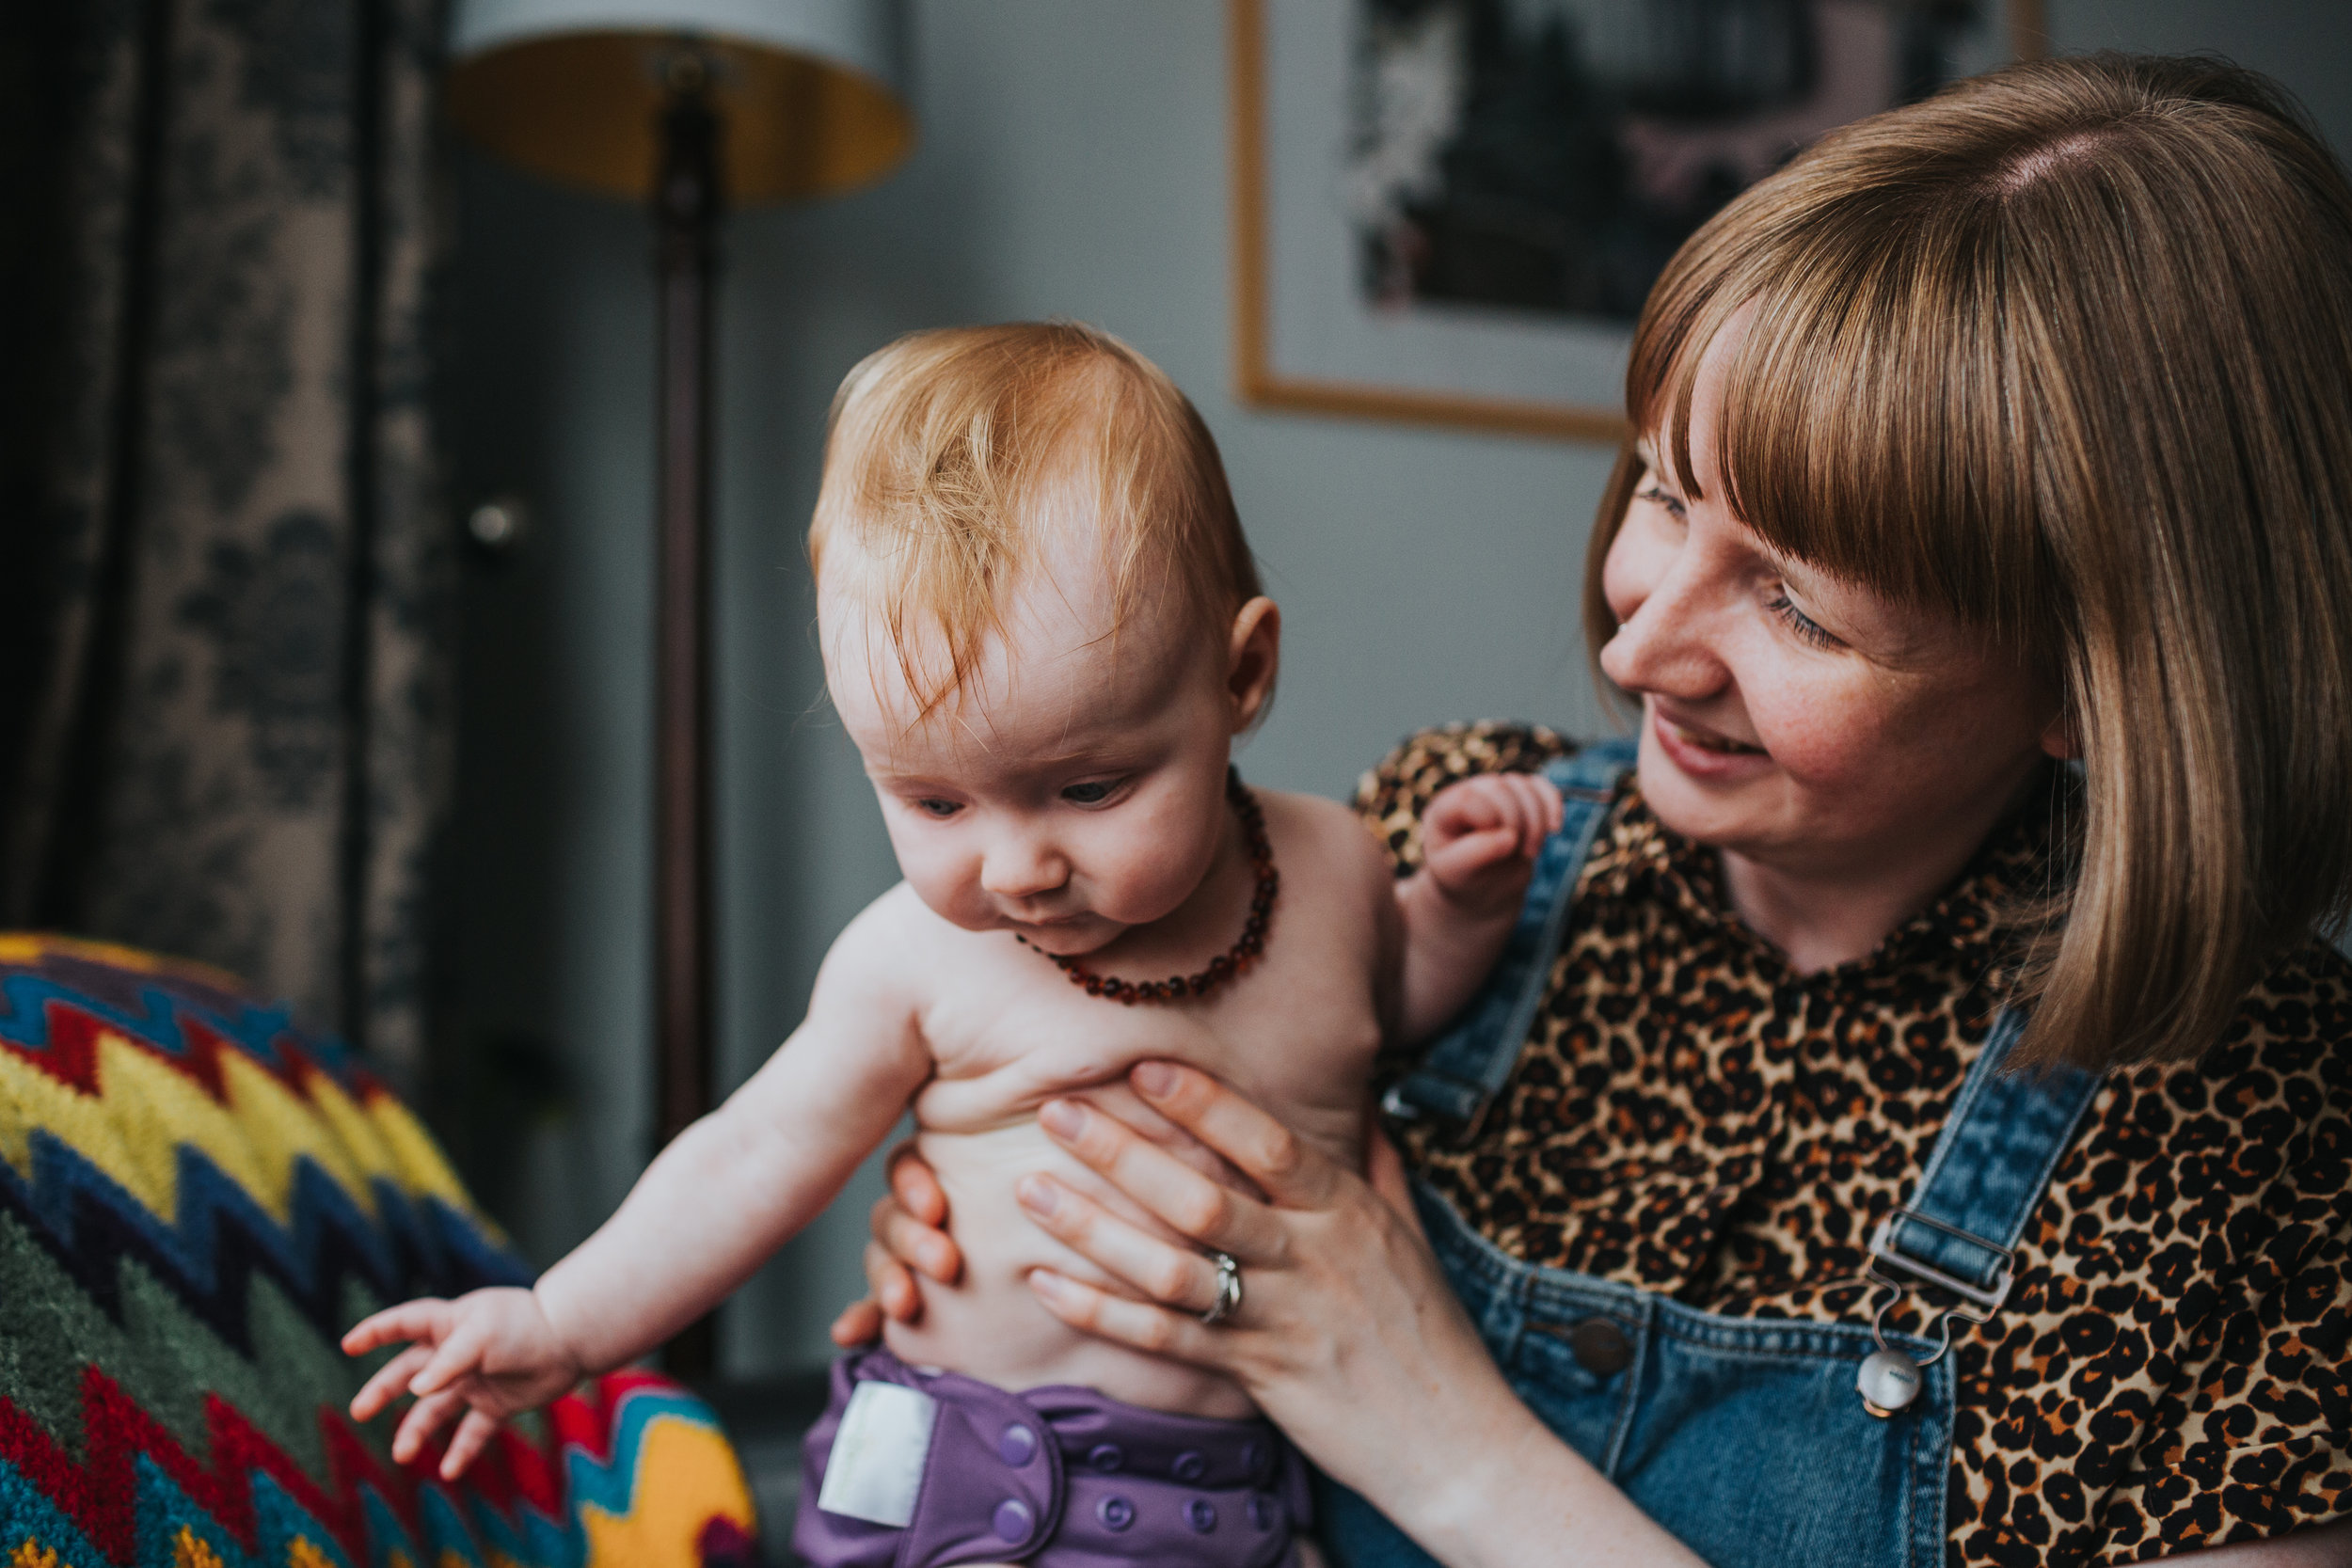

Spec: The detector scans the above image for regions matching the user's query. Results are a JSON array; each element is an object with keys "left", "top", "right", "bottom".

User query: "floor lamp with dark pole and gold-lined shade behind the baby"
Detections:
[{"left": 450, "top": 0, "right": 915, "bottom": 1380}]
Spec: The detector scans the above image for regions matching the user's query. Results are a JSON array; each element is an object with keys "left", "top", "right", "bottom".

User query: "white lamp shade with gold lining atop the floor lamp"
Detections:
[{"left": 447, "top": 0, "right": 915, "bottom": 207}]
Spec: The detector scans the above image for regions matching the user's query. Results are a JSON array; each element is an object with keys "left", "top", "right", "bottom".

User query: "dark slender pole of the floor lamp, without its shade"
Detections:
[{"left": 654, "top": 54, "right": 723, "bottom": 1383}]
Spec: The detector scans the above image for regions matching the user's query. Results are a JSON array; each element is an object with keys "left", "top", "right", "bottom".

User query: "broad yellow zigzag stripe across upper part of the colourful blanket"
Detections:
[{"left": 0, "top": 1030, "right": 477, "bottom": 1234}]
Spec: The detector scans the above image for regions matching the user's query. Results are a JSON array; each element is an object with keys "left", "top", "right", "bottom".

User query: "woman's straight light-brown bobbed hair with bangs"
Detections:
[{"left": 1585, "top": 54, "right": 2352, "bottom": 1068}]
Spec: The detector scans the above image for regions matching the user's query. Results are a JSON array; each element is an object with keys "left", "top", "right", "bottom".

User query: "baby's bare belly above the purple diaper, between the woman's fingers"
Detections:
[{"left": 887, "top": 1121, "right": 1251, "bottom": 1418}]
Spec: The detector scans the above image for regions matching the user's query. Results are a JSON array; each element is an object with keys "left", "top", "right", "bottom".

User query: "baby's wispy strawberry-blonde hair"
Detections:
[{"left": 809, "top": 322, "right": 1259, "bottom": 715}]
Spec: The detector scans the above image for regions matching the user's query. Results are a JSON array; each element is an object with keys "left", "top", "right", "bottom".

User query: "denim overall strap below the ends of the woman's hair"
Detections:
[{"left": 1870, "top": 1008, "right": 2101, "bottom": 1317}]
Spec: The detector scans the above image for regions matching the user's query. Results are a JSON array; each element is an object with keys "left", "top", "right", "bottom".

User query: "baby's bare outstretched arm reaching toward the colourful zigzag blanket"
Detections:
[{"left": 343, "top": 895, "right": 931, "bottom": 1479}]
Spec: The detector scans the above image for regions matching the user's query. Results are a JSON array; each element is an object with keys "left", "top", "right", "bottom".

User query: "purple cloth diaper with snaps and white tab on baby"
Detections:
[{"left": 793, "top": 1350, "right": 1311, "bottom": 1568}]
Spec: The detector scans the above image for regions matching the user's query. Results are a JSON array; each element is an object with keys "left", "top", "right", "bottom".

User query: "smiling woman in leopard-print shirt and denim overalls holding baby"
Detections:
[{"left": 845, "top": 56, "right": 2352, "bottom": 1566}]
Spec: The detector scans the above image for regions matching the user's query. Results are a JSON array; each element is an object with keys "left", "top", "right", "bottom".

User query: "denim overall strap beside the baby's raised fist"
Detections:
[{"left": 1383, "top": 740, "right": 1637, "bottom": 1138}]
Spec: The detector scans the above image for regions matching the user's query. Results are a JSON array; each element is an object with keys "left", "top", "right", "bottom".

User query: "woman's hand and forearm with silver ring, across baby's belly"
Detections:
[{"left": 1019, "top": 1063, "right": 1696, "bottom": 1566}]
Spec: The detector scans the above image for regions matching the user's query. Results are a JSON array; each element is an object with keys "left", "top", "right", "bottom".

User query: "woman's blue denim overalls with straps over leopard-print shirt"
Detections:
[{"left": 1317, "top": 740, "right": 2098, "bottom": 1568}]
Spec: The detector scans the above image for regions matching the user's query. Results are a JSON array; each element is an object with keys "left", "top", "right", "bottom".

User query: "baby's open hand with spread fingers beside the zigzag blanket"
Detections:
[{"left": 343, "top": 1289, "right": 586, "bottom": 1481}]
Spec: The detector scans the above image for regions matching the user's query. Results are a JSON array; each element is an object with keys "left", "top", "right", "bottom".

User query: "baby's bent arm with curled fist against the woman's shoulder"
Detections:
[{"left": 1397, "top": 773, "right": 1560, "bottom": 1041}]
